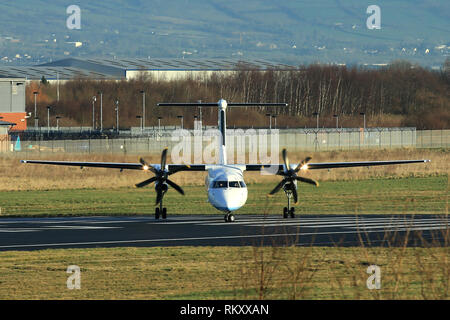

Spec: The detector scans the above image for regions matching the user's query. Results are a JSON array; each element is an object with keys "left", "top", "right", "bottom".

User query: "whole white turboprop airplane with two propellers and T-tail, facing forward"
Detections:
[{"left": 21, "top": 99, "right": 430, "bottom": 222}]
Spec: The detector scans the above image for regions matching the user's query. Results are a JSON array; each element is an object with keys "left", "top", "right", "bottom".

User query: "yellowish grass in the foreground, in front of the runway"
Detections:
[{"left": 0, "top": 247, "right": 450, "bottom": 299}]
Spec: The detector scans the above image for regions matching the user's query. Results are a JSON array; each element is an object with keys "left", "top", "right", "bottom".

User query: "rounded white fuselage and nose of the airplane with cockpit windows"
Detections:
[{"left": 205, "top": 165, "right": 247, "bottom": 212}]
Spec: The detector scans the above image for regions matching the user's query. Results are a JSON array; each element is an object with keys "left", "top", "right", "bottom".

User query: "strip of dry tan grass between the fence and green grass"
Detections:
[{"left": 0, "top": 149, "right": 450, "bottom": 191}]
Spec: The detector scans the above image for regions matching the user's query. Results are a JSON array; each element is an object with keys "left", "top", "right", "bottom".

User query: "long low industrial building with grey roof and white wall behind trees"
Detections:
[{"left": 0, "top": 58, "right": 294, "bottom": 81}]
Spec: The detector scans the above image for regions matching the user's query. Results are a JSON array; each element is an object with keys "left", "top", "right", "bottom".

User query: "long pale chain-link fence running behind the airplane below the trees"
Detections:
[{"left": 7, "top": 128, "right": 450, "bottom": 154}]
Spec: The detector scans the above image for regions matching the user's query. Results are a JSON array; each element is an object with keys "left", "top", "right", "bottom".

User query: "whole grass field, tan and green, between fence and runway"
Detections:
[{"left": 0, "top": 149, "right": 450, "bottom": 216}]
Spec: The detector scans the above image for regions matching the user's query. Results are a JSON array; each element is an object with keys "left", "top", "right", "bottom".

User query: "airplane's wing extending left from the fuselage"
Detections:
[{"left": 20, "top": 160, "right": 206, "bottom": 172}]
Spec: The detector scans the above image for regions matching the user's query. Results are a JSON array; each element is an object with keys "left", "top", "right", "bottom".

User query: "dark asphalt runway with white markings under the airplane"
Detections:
[{"left": 0, "top": 215, "right": 450, "bottom": 251}]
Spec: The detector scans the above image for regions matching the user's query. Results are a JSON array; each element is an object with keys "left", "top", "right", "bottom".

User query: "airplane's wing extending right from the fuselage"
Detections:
[{"left": 245, "top": 160, "right": 431, "bottom": 172}]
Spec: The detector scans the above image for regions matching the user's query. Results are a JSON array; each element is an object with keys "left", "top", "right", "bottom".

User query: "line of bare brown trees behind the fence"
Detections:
[{"left": 27, "top": 61, "right": 450, "bottom": 129}]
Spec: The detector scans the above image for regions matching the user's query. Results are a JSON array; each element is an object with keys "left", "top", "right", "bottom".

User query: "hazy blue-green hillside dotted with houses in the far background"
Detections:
[{"left": 0, "top": 0, "right": 450, "bottom": 66}]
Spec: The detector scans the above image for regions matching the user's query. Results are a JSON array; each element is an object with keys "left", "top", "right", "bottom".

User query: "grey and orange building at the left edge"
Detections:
[{"left": 0, "top": 78, "right": 27, "bottom": 131}]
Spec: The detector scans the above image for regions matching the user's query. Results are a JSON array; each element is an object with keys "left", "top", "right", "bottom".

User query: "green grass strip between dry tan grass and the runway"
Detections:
[{"left": 0, "top": 175, "right": 448, "bottom": 216}]
